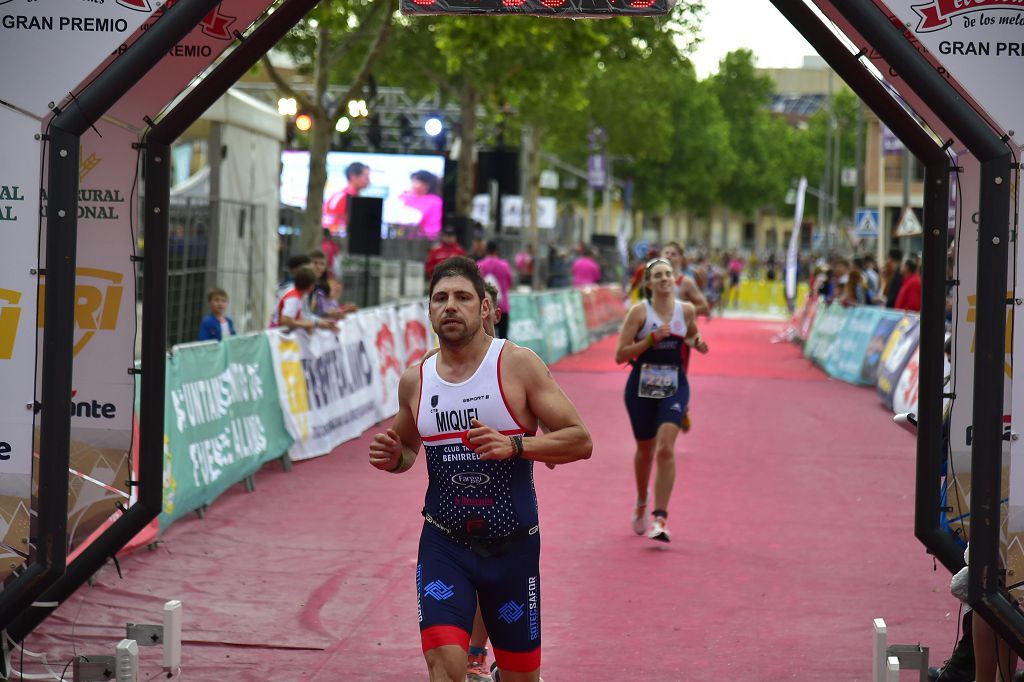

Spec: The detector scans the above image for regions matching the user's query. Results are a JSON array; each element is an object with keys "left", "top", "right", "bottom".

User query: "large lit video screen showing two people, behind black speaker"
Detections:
[{"left": 281, "top": 151, "right": 444, "bottom": 240}]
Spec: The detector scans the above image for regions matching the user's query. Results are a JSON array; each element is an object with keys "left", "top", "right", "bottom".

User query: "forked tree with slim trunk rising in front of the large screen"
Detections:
[{"left": 263, "top": 0, "right": 396, "bottom": 250}]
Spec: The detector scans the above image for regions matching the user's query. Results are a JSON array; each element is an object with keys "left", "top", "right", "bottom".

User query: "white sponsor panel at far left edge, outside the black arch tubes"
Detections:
[{"left": 0, "top": 104, "right": 42, "bottom": 583}]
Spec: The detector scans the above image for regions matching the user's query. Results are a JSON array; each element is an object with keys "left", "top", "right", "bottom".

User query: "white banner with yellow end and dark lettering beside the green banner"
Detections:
[{"left": 267, "top": 324, "right": 382, "bottom": 460}]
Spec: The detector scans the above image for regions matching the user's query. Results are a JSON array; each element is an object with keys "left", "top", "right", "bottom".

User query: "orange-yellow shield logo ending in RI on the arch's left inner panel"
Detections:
[{"left": 39, "top": 267, "right": 125, "bottom": 356}]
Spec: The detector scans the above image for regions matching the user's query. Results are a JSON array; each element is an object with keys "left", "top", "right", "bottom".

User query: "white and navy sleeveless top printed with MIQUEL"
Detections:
[{"left": 416, "top": 339, "right": 538, "bottom": 538}]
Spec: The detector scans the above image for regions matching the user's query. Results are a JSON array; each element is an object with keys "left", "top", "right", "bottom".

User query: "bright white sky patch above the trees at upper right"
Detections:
[{"left": 692, "top": 0, "right": 815, "bottom": 78}]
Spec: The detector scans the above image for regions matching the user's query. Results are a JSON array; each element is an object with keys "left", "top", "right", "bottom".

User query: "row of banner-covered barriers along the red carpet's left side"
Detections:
[{"left": 105, "top": 288, "right": 625, "bottom": 550}]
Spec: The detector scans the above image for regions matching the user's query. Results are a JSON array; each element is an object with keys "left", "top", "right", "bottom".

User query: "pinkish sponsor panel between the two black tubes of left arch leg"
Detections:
[{"left": 37, "top": 121, "right": 138, "bottom": 550}]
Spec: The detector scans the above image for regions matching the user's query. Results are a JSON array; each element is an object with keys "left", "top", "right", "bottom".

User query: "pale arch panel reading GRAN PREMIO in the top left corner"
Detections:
[{"left": 0, "top": 0, "right": 155, "bottom": 116}]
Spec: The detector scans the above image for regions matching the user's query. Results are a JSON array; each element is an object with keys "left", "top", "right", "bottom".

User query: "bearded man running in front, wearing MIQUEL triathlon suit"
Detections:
[{"left": 370, "top": 257, "right": 592, "bottom": 682}]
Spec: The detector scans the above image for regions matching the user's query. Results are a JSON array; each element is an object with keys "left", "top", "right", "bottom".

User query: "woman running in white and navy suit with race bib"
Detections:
[{"left": 615, "top": 258, "right": 708, "bottom": 543}]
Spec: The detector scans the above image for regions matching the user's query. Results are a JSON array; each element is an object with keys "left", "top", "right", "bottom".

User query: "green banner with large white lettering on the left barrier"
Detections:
[{"left": 160, "top": 334, "right": 292, "bottom": 528}]
